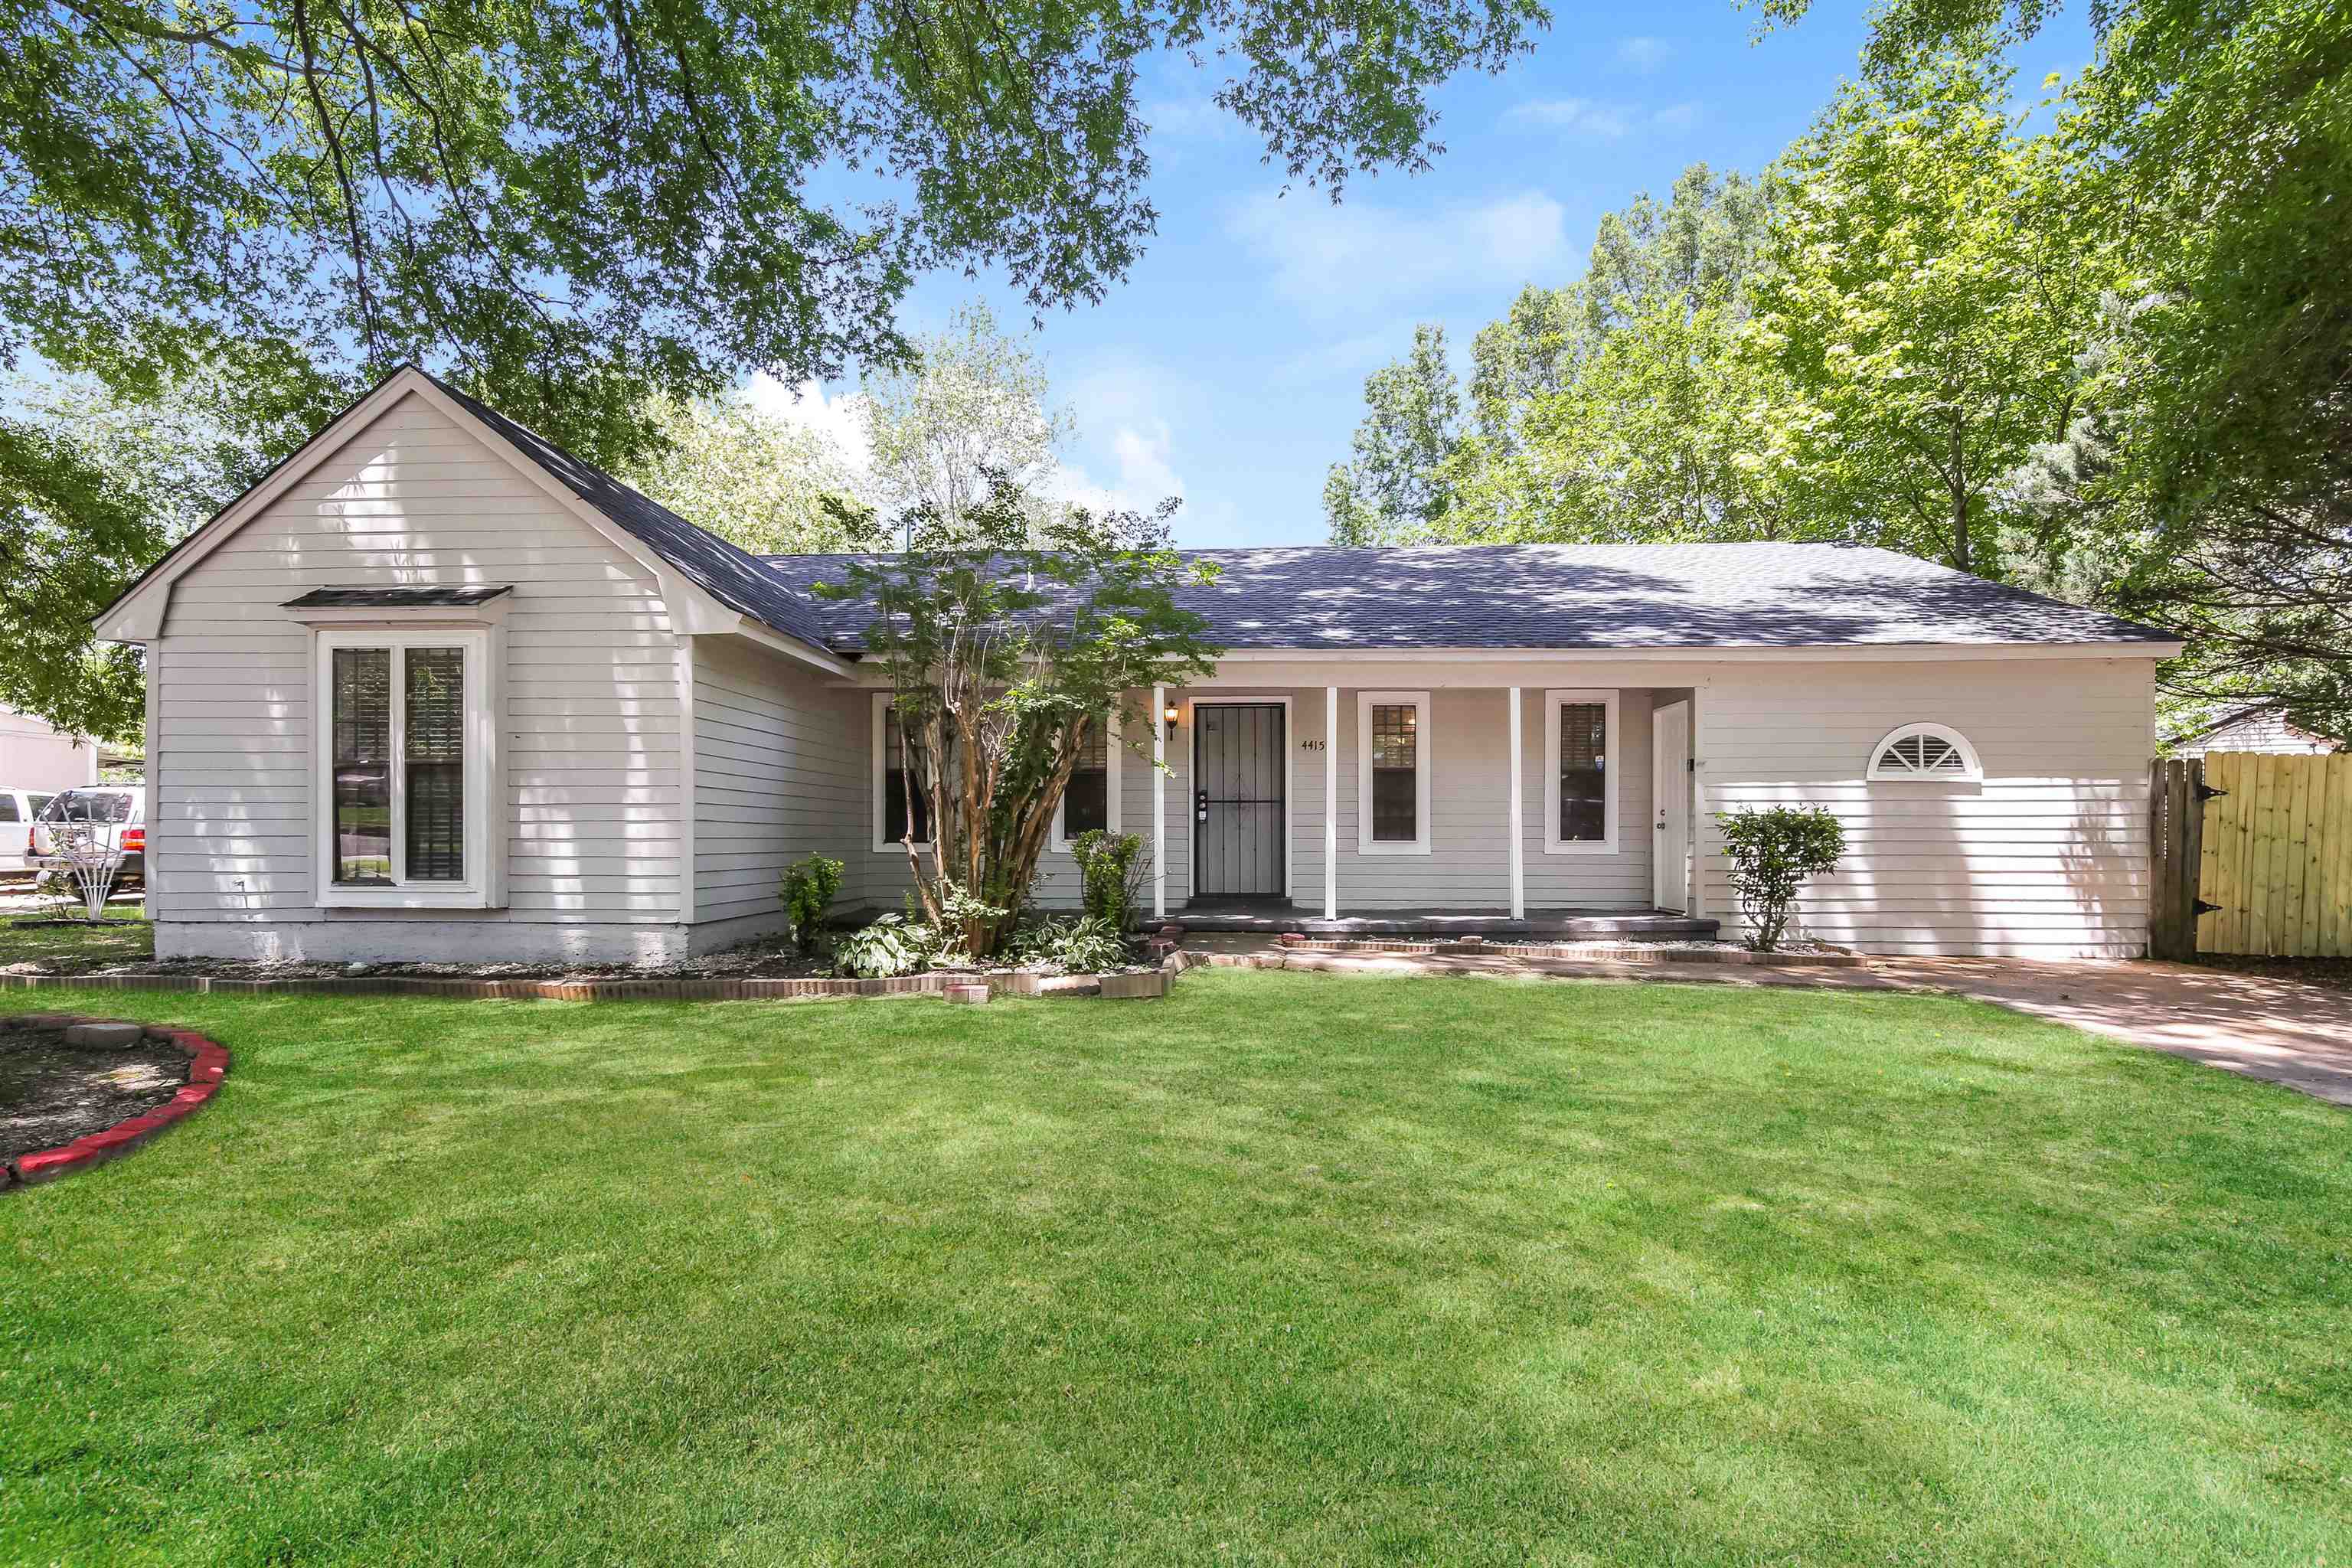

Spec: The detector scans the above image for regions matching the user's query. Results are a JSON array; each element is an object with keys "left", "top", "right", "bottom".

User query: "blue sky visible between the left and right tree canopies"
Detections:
[{"left": 757, "top": 0, "right": 2089, "bottom": 545}]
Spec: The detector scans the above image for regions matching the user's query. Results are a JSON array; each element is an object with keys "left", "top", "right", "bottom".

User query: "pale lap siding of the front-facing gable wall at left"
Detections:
[{"left": 153, "top": 397, "right": 682, "bottom": 945}]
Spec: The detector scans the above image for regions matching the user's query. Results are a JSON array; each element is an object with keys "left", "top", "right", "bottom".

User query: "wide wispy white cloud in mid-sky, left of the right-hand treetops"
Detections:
[{"left": 1226, "top": 191, "right": 1569, "bottom": 320}]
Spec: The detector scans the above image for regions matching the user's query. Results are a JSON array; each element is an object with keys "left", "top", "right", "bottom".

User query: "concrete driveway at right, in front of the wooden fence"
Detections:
[{"left": 1870, "top": 959, "right": 2352, "bottom": 1105}]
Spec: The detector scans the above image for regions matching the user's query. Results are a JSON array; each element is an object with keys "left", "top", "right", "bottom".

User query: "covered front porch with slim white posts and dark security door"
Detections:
[{"left": 1129, "top": 652, "right": 1717, "bottom": 940}]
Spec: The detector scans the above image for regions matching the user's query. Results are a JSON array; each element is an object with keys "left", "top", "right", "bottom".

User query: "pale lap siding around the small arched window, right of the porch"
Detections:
[{"left": 1698, "top": 661, "right": 2154, "bottom": 957}]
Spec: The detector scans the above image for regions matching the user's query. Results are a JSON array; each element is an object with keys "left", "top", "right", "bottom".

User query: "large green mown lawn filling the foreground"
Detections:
[{"left": 0, "top": 971, "right": 2352, "bottom": 1566}]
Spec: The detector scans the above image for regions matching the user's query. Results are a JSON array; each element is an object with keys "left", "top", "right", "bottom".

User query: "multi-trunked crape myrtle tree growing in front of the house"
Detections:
[{"left": 816, "top": 482, "right": 1223, "bottom": 959}]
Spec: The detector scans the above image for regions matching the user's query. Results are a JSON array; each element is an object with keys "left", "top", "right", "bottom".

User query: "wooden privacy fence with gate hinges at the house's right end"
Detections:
[{"left": 2148, "top": 753, "right": 2352, "bottom": 959}]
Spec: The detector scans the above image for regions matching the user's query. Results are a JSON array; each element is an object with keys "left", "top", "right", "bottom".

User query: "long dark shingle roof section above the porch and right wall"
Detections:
[{"left": 764, "top": 543, "right": 2174, "bottom": 648}]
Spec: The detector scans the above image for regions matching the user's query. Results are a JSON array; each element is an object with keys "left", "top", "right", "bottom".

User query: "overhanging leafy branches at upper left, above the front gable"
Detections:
[{"left": 0, "top": 0, "right": 1547, "bottom": 733}]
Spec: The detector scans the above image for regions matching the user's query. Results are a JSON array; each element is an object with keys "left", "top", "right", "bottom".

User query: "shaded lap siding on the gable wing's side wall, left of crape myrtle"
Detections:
[{"left": 694, "top": 637, "right": 868, "bottom": 924}]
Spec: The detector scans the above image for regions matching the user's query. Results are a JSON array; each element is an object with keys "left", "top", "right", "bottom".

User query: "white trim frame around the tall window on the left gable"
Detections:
[{"left": 311, "top": 629, "right": 505, "bottom": 910}]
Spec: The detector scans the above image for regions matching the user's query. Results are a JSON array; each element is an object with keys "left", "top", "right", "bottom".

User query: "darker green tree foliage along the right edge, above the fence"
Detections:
[{"left": 1764, "top": 0, "right": 2352, "bottom": 743}]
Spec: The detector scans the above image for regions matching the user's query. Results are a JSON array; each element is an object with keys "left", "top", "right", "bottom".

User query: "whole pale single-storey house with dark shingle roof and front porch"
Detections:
[{"left": 99, "top": 369, "right": 2178, "bottom": 959}]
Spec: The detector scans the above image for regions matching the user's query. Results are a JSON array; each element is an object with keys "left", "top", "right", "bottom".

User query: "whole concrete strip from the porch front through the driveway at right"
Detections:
[{"left": 1185, "top": 936, "right": 2352, "bottom": 1107}]
